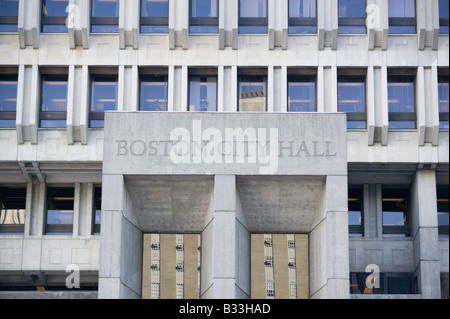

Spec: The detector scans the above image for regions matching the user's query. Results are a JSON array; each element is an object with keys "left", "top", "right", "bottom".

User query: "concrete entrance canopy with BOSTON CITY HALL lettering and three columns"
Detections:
[{"left": 99, "top": 112, "right": 349, "bottom": 299}]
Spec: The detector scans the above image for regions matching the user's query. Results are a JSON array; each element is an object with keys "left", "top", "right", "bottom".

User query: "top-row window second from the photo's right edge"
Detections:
[{"left": 388, "top": 0, "right": 417, "bottom": 34}]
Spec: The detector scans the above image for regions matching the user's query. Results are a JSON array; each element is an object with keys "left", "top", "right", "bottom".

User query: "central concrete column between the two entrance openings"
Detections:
[{"left": 201, "top": 175, "right": 250, "bottom": 299}]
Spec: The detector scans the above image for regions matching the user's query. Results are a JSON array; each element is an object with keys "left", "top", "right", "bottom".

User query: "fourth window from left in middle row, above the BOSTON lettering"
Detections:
[{"left": 139, "top": 74, "right": 168, "bottom": 111}]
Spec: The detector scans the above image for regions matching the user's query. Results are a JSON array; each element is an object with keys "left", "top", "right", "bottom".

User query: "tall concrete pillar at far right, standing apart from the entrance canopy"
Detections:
[{"left": 410, "top": 170, "right": 441, "bottom": 299}]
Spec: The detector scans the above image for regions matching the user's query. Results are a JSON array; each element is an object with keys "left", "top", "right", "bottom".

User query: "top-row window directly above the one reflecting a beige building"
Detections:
[{"left": 239, "top": 0, "right": 268, "bottom": 34}]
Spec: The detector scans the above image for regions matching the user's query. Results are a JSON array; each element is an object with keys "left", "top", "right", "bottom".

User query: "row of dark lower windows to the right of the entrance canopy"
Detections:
[{"left": 348, "top": 187, "right": 449, "bottom": 237}]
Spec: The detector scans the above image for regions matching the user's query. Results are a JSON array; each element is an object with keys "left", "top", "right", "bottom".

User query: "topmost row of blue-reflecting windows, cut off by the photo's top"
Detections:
[{"left": 0, "top": 0, "right": 449, "bottom": 34}]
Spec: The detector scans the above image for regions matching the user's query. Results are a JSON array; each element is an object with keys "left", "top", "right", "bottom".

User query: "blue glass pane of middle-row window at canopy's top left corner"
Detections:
[{"left": 91, "top": 77, "right": 117, "bottom": 112}]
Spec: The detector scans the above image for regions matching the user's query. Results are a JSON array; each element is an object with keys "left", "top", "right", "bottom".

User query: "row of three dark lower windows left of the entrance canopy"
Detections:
[{"left": 0, "top": 187, "right": 102, "bottom": 235}]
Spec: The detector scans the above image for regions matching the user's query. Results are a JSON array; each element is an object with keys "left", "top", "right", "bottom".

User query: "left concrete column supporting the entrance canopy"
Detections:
[{"left": 98, "top": 175, "right": 143, "bottom": 299}]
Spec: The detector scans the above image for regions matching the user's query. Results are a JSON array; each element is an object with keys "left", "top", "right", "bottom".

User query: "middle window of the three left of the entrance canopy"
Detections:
[{"left": 45, "top": 187, "right": 74, "bottom": 235}]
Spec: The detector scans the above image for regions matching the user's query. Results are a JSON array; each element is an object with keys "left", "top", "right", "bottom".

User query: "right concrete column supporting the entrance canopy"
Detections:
[{"left": 309, "top": 176, "right": 349, "bottom": 299}]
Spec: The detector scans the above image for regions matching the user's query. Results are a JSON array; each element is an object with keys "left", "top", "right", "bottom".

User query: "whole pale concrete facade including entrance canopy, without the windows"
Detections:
[{"left": 0, "top": 0, "right": 449, "bottom": 299}]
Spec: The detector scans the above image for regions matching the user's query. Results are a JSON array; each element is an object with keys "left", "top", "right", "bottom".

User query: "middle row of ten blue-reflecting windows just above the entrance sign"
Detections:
[{"left": 0, "top": 68, "right": 449, "bottom": 129}]
